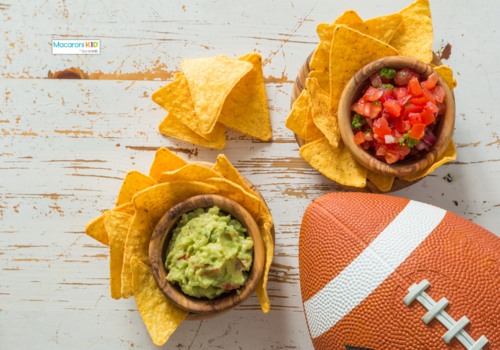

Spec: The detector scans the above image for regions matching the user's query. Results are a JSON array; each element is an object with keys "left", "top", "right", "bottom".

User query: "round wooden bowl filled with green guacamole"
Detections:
[{"left": 149, "top": 195, "right": 265, "bottom": 315}]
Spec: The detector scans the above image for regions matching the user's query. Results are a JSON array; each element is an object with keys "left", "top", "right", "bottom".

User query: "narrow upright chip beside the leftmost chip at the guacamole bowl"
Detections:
[{"left": 104, "top": 211, "right": 132, "bottom": 299}]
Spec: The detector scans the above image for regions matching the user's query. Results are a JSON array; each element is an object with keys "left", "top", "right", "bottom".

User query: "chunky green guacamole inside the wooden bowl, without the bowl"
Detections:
[{"left": 165, "top": 207, "right": 253, "bottom": 299}]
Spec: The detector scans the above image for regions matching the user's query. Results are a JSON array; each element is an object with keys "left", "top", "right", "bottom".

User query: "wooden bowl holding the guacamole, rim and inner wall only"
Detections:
[{"left": 149, "top": 194, "right": 265, "bottom": 314}]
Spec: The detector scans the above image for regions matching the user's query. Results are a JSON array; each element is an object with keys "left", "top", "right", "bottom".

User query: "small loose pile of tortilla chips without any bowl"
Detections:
[{"left": 152, "top": 53, "right": 272, "bottom": 149}]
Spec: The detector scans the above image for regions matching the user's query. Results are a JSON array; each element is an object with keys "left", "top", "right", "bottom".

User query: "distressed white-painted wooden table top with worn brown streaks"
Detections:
[{"left": 0, "top": 0, "right": 500, "bottom": 350}]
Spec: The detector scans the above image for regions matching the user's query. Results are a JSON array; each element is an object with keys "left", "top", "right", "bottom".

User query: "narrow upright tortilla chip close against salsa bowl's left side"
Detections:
[{"left": 306, "top": 79, "right": 340, "bottom": 148}]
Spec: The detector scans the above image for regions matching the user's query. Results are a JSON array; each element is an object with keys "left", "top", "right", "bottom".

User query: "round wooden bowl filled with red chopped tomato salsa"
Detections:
[{"left": 338, "top": 56, "right": 455, "bottom": 177}]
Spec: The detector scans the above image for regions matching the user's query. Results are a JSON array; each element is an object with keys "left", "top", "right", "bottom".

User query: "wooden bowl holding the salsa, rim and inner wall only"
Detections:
[{"left": 338, "top": 56, "right": 455, "bottom": 177}]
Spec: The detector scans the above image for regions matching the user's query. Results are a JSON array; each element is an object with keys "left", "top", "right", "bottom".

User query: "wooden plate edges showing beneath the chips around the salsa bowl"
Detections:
[{"left": 290, "top": 50, "right": 454, "bottom": 193}]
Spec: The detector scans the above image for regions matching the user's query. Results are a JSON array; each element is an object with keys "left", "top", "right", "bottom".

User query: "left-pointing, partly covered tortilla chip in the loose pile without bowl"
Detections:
[{"left": 151, "top": 73, "right": 224, "bottom": 141}]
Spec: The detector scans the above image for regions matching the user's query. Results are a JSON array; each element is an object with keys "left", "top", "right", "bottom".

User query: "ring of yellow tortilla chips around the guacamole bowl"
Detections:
[{"left": 85, "top": 147, "right": 274, "bottom": 345}]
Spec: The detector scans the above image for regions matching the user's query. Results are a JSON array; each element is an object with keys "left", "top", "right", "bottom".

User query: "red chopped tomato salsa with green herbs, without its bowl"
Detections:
[{"left": 351, "top": 68, "right": 446, "bottom": 164}]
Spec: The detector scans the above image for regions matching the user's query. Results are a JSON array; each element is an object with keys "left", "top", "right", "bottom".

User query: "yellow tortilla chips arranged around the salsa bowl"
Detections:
[{"left": 286, "top": 0, "right": 457, "bottom": 192}]
